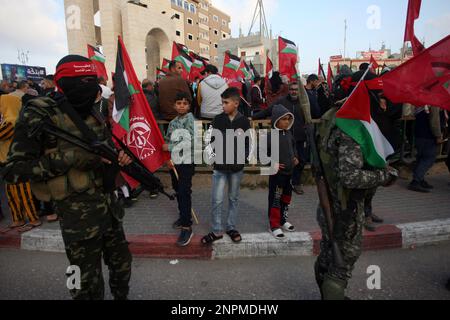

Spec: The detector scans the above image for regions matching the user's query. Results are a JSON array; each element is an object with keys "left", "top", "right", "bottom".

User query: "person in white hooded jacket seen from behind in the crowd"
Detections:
[{"left": 197, "top": 64, "right": 228, "bottom": 120}]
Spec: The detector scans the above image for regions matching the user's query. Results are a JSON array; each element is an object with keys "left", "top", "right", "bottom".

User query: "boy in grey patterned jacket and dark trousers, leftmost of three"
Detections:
[{"left": 163, "top": 92, "right": 195, "bottom": 247}]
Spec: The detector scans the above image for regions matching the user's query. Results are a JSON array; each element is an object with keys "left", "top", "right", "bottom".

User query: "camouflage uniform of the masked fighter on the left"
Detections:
[{"left": 2, "top": 98, "right": 132, "bottom": 299}]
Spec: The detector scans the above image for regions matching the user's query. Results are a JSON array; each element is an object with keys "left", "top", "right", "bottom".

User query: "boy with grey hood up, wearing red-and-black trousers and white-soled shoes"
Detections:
[{"left": 268, "top": 105, "right": 299, "bottom": 240}]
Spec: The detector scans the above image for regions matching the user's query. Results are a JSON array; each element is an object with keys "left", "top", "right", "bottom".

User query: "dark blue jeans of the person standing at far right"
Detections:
[{"left": 414, "top": 138, "right": 437, "bottom": 182}]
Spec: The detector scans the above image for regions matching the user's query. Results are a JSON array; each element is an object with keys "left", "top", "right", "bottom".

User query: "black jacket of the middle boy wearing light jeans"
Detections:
[{"left": 212, "top": 113, "right": 252, "bottom": 172}]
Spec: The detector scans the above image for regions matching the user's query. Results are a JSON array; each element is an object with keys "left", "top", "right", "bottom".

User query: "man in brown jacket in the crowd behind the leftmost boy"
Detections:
[{"left": 159, "top": 61, "right": 192, "bottom": 121}]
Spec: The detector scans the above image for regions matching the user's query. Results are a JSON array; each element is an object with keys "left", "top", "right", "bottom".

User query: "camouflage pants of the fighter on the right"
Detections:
[{"left": 316, "top": 201, "right": 364, "bottom": 282}]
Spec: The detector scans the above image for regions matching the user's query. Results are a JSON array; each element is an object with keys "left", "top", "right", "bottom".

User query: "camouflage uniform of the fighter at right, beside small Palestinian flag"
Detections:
[{"left": 316, "top": 110, "right": 390, "bottom": 298}]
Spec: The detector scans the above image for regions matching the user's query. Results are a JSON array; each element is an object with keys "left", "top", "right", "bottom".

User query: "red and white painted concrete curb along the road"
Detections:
[{"left": 0, "top": 219, "right": 450, "bottom": 260}]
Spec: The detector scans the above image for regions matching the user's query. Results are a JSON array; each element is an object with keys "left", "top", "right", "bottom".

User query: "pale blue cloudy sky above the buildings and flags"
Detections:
[{"left": 0, "top": 0, "right": 450, "bottom": 73}]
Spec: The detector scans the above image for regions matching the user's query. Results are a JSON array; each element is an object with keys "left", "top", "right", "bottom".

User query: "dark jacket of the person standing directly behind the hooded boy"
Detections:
[{"left": 253, "top": 95, "right": 307, "bottom": 142}]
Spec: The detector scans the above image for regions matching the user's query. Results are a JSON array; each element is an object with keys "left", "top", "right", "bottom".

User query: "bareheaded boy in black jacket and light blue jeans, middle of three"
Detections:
[{"left": 202, "top": 88, "right": 251, "bottom": 245}]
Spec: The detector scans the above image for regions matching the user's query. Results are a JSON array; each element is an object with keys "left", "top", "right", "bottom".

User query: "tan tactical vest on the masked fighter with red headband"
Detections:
[{"left": 27, "top": 98, "right": 106, "bottom": 202}]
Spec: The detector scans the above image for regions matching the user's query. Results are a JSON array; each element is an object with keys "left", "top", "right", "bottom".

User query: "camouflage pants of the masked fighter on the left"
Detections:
[{"left": 66, "top": 222, "right": 132, "bottom": 300}]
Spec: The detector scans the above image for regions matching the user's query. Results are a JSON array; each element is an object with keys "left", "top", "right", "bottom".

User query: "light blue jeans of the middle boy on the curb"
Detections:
[{"left": 212, "top": 170, "right": 244, "bottom": 235}]
